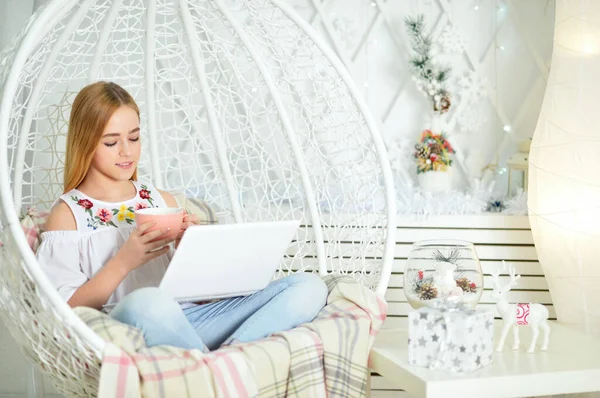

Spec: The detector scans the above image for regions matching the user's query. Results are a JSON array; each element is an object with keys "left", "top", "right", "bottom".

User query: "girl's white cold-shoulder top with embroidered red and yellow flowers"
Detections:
[{"left": 36, "top": 181, "right": 173, "bottom": 304}]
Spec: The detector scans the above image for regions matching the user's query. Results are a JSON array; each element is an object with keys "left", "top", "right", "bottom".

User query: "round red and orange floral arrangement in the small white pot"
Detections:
[{"left": 413, "top": 130, "right": 455, "bottom": 174}]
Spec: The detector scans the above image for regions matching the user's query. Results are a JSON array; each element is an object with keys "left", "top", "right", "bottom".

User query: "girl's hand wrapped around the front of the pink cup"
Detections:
[{"left": 115, "top": 221, "right": 173, "bottom": 272}]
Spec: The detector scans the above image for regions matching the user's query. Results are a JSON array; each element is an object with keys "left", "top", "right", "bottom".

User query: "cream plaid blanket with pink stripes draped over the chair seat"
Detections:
[{"left": 76, "top": 276, "right": 387, "bottom": 398}]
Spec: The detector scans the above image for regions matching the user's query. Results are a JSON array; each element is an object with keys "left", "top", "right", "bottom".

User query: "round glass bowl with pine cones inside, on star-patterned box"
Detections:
[{"left": 404, "top": 240, "right": 483, "bottom": 309}]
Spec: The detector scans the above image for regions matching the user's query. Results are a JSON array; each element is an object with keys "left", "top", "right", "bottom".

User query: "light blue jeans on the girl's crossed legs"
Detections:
[{"left": 109, "top": 273, "right": 327, "bottom": 351}]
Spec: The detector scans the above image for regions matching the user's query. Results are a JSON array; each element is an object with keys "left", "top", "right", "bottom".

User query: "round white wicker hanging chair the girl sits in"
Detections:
[{"left": 0, "top": 0, "right": 395, "bottom": 396}]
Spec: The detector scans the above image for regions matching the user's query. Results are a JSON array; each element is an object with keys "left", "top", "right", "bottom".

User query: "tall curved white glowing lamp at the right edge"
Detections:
[{"left": 528, "top": 0, "right": 600, "bottom": 337}]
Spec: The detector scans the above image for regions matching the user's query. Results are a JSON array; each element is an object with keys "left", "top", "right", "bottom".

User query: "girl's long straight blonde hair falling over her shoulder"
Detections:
[{"left": 64, "top": 82, "right": 140, "bottom": 193}]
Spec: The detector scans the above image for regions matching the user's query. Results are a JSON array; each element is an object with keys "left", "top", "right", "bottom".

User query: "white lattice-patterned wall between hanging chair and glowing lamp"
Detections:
[{"left": 287, "top": 0, "right": 554, "bottom": 196}]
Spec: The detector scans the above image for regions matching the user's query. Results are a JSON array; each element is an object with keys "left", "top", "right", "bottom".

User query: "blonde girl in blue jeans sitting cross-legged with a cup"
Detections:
[{"left": 37, "top": 82, "right": 327, "bottom": 350}]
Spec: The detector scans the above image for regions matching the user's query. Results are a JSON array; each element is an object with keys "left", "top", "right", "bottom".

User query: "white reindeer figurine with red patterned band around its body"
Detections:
[{"left": 491, "top": 261, "right": 550, "bottom": 353}]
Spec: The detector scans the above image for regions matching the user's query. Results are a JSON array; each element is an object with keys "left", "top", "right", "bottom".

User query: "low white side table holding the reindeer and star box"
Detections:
[{"left": 369, "top": 322, "right": 600, "bottom": 398}]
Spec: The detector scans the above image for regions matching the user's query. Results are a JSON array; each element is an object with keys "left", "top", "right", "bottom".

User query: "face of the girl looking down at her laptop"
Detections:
[{"left": 90, "top": 106, "right": 141, "bottom": 181}]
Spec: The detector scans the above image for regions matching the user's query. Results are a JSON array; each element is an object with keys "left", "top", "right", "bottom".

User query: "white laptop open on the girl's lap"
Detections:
[{"left": 159, "top": 220, "right": 300, "bottom": 302}]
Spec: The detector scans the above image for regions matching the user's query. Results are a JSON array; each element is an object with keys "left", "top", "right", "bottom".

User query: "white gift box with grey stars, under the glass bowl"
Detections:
[{"left": 408, "top": 307, "right": 494, "bottom": 372}]
